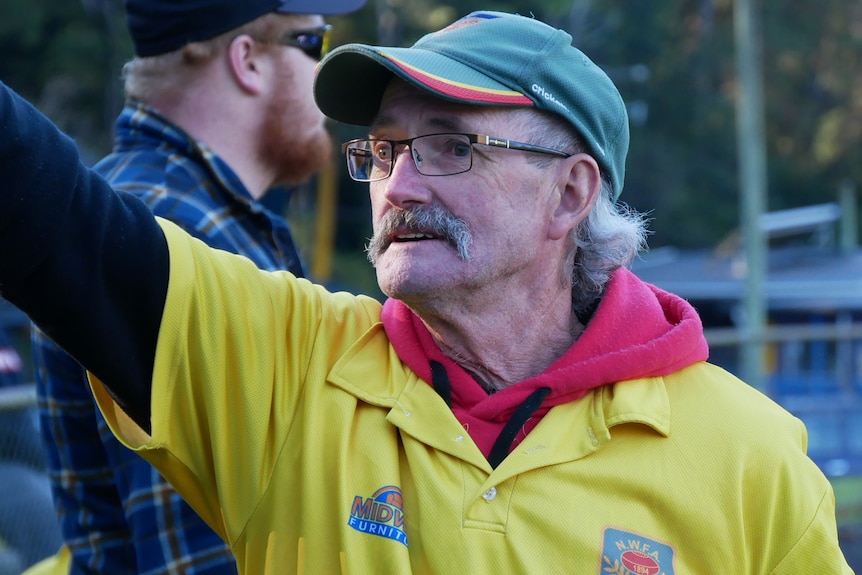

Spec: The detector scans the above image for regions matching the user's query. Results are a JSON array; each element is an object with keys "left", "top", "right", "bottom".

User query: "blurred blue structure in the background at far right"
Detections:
[{"left": 633, "top": 202, "right": 862, "bottom": 477}]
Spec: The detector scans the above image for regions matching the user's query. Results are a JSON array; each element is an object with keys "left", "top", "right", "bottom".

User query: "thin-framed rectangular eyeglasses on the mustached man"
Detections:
[{"left": 341, "top": 134, "right": 571, "bottom": 182}]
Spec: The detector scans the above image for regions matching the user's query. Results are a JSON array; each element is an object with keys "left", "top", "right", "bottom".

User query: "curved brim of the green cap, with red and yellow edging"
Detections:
[{"left": 314, "top": 44, "right": 534, "bottom": 126}]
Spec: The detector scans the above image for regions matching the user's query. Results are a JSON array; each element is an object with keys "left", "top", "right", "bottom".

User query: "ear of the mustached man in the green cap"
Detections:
[{"left": 548, "top": 154, "right": 602, "bottom": 239}]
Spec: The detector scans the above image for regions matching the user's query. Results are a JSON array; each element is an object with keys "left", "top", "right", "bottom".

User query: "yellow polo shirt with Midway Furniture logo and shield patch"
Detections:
[{"left": 93, "top": 222, "right": 851, "bottom": 575}]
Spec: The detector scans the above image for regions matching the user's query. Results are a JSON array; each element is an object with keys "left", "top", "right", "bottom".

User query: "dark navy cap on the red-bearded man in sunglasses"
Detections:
[{"left": 125, "top": 0, "right": 366, "bottom": 57}]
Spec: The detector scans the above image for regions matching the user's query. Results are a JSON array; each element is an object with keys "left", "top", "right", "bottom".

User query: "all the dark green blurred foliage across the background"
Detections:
[{"left": 0, "top": 0, "right": 862, "bottom": 254}]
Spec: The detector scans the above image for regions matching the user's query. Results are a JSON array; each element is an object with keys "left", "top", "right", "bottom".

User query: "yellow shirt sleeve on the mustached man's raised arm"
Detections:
[{"left": 91, "top": 220, "right": 380, "bottom": 541}]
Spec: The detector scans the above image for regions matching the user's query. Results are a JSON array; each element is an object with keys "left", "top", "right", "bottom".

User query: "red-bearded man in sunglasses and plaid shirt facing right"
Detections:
[{"left": 28, "top": 0, "right": 364, "bottom": 575}]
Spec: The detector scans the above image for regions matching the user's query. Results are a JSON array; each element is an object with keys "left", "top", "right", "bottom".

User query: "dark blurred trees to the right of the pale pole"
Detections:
[{"left": 764, "top": 0, "right": 862, "bottom": 213}]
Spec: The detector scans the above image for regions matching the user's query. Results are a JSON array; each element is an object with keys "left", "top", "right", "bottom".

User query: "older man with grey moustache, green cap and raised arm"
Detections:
[{"left": 0, "top": 12, "right": 850, "bottom": 574}]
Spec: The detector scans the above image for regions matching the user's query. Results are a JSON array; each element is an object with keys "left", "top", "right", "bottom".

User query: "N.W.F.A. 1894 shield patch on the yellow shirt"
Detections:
[{"left": 601, "top": 527, "right": 674, "bottom": 575}]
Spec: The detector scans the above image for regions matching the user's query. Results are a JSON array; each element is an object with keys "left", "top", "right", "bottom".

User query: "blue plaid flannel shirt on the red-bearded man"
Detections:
[{"left": 32, "top": 102, "right": 303, "bottom": 575}]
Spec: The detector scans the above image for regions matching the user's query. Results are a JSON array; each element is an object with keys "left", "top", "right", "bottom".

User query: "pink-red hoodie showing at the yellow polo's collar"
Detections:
[{"left": 382, "top": 268, "right": 709, "bottom": 457}]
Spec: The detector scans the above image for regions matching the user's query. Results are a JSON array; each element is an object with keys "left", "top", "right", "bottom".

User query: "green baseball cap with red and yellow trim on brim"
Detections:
[{"left": 314, "top": 11, "right": 629, "bottom": 200}]
